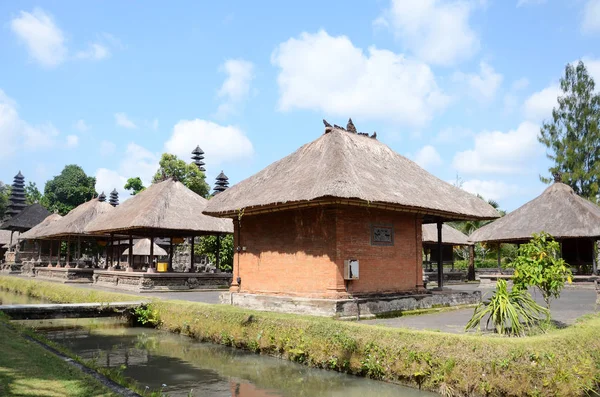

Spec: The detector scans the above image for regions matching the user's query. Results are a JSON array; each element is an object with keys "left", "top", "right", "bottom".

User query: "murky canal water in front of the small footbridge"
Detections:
[{"left": 21, "top": 319, "right": 433, "bottom": 397}]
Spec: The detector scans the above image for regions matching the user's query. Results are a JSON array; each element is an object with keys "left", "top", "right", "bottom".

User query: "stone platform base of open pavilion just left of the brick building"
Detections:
[{"left": 93, "top": 270, "right": 231, "bottom": 292}]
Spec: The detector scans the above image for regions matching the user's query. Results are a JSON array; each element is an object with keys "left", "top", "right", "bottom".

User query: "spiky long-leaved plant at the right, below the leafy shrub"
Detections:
[{"left": 465, "top": 280, "right": 548, "bottom": 336}]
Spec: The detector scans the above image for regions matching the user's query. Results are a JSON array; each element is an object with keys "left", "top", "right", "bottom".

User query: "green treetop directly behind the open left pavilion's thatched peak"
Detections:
[{"left": 152, "top": 153, "right": 210, "bottom": 197}]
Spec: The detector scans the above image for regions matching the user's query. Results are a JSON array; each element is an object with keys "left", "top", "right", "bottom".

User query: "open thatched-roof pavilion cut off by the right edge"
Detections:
[{"left": 469, "top": 175, "right": 600, "bottom": 274}]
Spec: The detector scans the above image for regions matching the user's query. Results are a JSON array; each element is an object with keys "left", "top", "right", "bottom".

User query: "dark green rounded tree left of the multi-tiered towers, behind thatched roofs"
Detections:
[{"left": 41, "top": 164, "right": 97, "bottom": 215}]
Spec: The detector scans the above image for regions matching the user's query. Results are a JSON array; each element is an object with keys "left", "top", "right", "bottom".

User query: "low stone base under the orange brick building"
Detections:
[{"left": 220, "top": 290, "right": 481, "bottom": 319}]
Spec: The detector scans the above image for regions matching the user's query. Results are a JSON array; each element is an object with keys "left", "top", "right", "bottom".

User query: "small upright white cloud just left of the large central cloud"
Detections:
[{"left": 217, "top": 59, "right": 254, "bottom": 116}]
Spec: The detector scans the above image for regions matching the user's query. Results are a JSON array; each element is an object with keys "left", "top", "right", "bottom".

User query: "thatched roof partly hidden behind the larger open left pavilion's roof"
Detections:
[{"left": 37, "top": 198, "right": 115, "bottom": 239}]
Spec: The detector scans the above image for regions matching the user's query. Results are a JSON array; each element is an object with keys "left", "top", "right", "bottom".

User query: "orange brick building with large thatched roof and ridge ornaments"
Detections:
[{"left": 205, "top": 120, "right": 498, "bottom": 315}]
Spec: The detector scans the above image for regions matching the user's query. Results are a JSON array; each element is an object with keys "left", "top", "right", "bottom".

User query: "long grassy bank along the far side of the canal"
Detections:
[{"left": 0, "top": 277, "right": 600, "bottom": 396}]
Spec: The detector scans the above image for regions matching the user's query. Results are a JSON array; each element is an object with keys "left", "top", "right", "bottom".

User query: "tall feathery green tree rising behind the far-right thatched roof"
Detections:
[{"left": 538, "top": 61, "right": 600, "bottom": 202}]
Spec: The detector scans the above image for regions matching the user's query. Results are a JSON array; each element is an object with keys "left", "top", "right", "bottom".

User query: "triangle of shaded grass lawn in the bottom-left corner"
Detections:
[{"left": 0, "top": 318, "right": 116, "bottom": 397}]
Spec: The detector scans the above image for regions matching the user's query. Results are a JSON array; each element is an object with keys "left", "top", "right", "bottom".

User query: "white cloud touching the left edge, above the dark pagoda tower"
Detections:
[{"left": 0, "top": 89, "right": 59, "bottom": 156}]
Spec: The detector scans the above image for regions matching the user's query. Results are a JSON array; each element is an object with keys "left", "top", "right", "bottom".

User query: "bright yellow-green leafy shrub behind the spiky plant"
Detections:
[{"left": 512, "top": 232, "right": 572, "bottom": 309}]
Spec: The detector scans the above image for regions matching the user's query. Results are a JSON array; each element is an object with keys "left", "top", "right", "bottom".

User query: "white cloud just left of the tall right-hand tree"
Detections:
[{"left": 452, "top": 121, "right": 544, "bottom": 174}]
